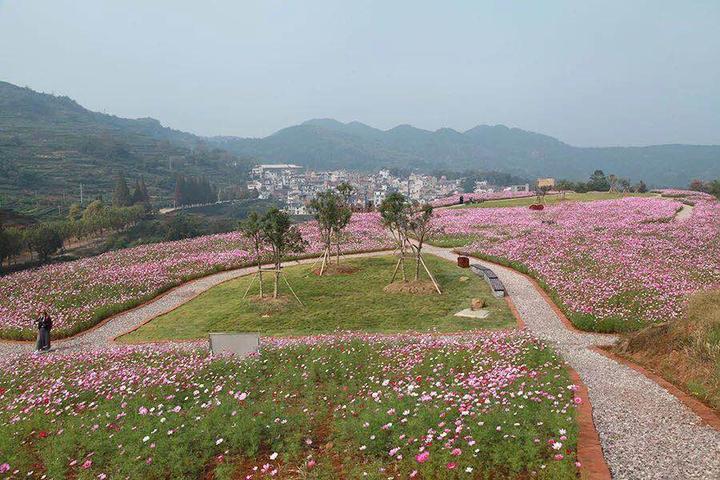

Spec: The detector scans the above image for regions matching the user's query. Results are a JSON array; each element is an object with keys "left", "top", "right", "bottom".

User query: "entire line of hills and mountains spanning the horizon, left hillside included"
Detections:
[{"left": 0, "top": 82, "right": 720, "bottom": 218}]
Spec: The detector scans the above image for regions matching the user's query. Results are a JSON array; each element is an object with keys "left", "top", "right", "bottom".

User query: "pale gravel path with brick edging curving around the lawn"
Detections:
[{"left": 0, "top": 245, "right": 720, "bottom": 480}]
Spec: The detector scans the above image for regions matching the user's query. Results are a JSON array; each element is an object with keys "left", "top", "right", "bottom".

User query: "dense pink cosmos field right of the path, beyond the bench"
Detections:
[{"left": 435, "top": 190, "right": 720, "bottom": 331}]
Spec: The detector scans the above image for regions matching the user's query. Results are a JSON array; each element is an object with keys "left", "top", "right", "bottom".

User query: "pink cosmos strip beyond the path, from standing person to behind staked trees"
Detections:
[{"left": 0, "top": 213, "right": 390, "bottom": 340}]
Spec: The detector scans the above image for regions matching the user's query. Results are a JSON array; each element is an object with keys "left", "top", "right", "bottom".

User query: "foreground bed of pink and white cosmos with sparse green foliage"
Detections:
[{"left": 0, "top": 330, "right": 580, "bottom": 480}]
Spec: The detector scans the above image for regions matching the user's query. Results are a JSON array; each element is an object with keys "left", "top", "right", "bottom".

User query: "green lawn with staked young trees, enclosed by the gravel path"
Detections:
[{"left": 120, "top": 255, "right": 515, "bottom": 342}]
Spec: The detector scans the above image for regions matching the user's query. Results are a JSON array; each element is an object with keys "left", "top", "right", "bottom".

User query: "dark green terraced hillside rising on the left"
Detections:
[{"left": 0, "top": 82, "right": 249, "bottom": 213}]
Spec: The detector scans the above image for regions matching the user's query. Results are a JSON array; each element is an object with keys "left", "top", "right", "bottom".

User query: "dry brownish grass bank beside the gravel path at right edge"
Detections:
[{"left": 616, "top": 290, "right": 720, "bottom": 411}]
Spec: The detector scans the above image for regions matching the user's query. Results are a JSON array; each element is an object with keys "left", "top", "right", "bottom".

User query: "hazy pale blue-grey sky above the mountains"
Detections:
[{"left": 0, "top": 0, "right": 720, "bottom": 146}]
